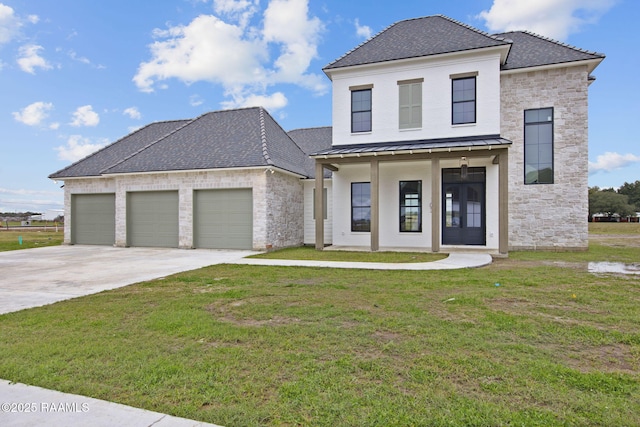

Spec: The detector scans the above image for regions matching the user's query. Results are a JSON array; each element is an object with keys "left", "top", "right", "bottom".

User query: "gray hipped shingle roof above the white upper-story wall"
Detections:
[{"left": 324, "top": 15, "right": 509, "bottom": 70}]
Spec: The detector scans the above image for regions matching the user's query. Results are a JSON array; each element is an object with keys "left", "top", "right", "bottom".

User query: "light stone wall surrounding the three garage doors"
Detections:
[{"left": 64, "top": 168, "right": 304, "bottom": 250}]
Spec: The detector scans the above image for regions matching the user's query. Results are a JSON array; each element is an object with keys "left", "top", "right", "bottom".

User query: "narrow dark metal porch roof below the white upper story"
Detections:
[{"left": 311, "top": 135, "right": 512, "bottom": 159}]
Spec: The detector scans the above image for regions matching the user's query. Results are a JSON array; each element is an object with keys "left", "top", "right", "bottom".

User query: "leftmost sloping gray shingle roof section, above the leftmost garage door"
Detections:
[{"left": 49, "top": 120, "right": 190, "bottom": 179}]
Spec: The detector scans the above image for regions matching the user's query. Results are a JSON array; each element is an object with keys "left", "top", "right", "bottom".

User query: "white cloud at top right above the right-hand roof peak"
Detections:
[{"left": 478, "top": 0, "right": 616, "bottom": 40}]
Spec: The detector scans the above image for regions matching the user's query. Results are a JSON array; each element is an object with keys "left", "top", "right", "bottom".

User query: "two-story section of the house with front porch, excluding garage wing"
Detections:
[{"left": 312, "top": 16, "right": 604, "bottom": 253}]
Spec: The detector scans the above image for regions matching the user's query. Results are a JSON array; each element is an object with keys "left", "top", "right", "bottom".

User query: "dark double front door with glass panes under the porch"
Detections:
[{"left": 442, "top": 168, "right": 486, "bottom": 245}]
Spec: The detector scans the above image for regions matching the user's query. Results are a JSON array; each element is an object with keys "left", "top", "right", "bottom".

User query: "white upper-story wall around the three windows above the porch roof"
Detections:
[{"left": 332, "top": 52, "right": 500, "bottom": 145}]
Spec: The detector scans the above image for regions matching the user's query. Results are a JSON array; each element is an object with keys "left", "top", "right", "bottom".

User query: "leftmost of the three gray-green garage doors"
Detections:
[{"left": 71, "top": 194, "right": 116, "bottom": 245}]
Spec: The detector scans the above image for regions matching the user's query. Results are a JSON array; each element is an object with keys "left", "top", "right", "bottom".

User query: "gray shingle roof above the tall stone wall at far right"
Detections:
[{"left": 497, "top": 31, "right": 604, "bottom": 70}]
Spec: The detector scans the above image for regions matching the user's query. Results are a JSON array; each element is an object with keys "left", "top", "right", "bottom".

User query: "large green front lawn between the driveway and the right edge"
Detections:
[{"left": 0, "top": 226, "right": 640, "bottom": 426}]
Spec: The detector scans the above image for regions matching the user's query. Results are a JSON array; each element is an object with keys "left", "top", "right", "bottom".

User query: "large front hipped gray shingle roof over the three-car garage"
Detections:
[{"left": 50, "top": 107, "right": 313, "bottom": 179}]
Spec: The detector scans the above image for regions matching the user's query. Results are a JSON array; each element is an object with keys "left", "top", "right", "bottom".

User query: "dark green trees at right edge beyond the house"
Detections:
[{"left": 589, "top": 181, "right": 640, "bottom": 220}]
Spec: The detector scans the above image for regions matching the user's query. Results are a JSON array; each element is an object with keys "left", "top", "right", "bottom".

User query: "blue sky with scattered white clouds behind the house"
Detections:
[{"left": 0, "top": 0, "right": 640, "bottom": 212}]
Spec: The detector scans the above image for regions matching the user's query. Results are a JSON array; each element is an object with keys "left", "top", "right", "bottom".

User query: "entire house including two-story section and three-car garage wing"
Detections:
[{"left": 50, "top": 16, "right": 604, "bottom": 253}]
